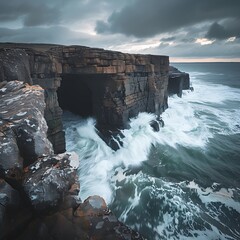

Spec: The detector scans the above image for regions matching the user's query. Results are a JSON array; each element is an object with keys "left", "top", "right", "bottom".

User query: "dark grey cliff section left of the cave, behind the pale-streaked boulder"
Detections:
[{"left": 0, "top": 45, "right": 65, "bottom": 153}]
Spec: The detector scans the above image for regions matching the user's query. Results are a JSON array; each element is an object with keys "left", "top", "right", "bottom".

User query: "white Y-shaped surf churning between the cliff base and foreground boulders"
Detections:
[{"left": 66, "top": 113, "right": 157, "bottom": 202}]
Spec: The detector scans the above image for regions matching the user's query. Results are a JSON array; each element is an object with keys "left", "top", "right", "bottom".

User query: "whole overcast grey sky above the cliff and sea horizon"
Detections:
[{"left": 0, "top": 0, "right": 240, "bottom": 62}]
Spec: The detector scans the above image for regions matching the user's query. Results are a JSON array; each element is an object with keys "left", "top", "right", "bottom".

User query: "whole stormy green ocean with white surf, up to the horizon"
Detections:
[{"left": 64, "top": 63, "right": 240, "bottom": 240}]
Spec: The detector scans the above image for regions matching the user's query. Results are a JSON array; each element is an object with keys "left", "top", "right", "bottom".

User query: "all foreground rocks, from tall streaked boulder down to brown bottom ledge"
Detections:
[{"left": 0, "top": 81, "right": 143, "bottom": 240}]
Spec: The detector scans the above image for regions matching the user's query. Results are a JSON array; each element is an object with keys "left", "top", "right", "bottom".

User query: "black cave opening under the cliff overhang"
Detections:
[{"left": 57, "top": 74, "right": 93, "bottom": 117}]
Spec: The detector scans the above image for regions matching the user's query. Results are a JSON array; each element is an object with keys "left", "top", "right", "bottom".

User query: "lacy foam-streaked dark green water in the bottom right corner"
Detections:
[{"left": 116, "top": 172, "right": 240, "bottom": 240}]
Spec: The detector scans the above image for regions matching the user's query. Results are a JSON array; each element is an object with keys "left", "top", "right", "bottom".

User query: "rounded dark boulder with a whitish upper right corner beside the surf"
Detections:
[{"left": 22, "top": 154, "right": 79, "bottom": 213}]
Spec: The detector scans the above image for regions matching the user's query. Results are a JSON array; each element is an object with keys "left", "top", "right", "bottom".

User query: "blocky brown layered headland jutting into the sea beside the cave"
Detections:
[{"left": 59, "top": 47, "right": 169, "bottom": 128}]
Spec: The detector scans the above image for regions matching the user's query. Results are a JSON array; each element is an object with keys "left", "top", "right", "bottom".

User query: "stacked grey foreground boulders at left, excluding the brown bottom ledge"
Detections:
[{"left": 0, "top": 81, "right": 77, "bottom": 239}]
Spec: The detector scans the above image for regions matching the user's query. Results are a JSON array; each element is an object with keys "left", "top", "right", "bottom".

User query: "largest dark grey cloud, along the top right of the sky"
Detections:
[{"left": 96, "top": 0, "right": 240, "bottom": 37}]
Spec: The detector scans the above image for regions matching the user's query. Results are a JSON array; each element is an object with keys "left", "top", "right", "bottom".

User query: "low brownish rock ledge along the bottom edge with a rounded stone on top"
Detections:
[{"left": 17, "top": 196, "right": 146, "bottom": 240}]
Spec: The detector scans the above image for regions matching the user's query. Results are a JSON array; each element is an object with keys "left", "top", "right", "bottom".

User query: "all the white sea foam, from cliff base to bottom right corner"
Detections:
[{"left": 65, "top": 74, "right": 240, "bottom": 239}]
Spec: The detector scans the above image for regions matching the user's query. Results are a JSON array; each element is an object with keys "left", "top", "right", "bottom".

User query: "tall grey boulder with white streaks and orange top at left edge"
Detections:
[{"left": 0, "top": 81, "right": 52, "bottom": 174}]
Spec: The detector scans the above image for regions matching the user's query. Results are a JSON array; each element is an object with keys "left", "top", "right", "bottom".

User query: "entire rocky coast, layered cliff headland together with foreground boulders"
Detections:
[{"left": 0, "top": 44, "right": 189, "bottom": 240}]
